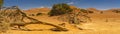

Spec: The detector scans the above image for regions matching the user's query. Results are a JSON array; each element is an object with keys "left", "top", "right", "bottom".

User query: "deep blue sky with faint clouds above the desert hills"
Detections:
[{"left": 4, "top": 0, "right": 120, "bottom": 9}]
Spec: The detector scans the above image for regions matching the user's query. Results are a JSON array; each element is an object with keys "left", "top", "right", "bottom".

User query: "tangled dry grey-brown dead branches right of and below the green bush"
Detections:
[{"left": 58, "top": 8, "right": 91, "bottom": 30}]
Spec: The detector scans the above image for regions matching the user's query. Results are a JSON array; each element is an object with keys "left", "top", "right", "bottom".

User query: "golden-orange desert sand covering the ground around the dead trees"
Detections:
[{"left": 1, "top": 7, "right": 120, "bottom": 34}]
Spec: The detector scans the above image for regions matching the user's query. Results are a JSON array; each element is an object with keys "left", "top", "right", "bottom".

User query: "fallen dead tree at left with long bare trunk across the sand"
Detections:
[{"left": 0, "top": 6, "right": 67, "bottom": 31}]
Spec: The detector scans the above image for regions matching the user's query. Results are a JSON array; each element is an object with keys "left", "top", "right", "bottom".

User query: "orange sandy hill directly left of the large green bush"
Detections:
[{"left": 24, "top": 7, "right": 50, "bottom": 14}]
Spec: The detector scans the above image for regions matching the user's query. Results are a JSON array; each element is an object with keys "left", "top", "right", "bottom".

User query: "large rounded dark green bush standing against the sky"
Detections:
[{"left": 48, "top": 3, "right": 72, "bottom": 16}]
